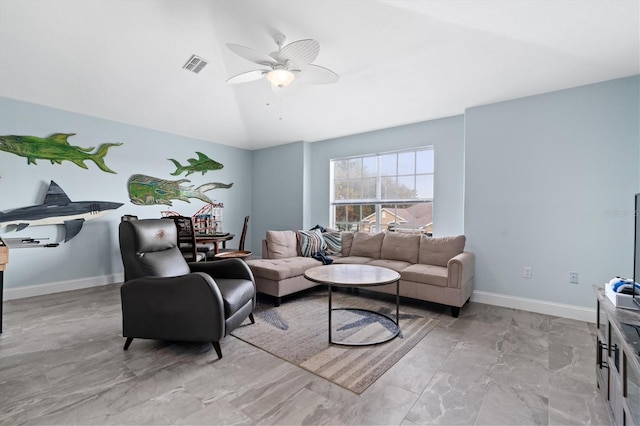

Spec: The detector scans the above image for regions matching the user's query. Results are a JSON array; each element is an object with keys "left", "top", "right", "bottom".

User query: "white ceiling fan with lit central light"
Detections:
[{"left": 227, "top": 34, "right": 340, "bottom": 88}]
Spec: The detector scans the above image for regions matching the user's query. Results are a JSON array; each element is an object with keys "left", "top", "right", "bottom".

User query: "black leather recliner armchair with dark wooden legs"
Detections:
[{"left": 119, "top": 219, "right": 256, "bottom": 358}]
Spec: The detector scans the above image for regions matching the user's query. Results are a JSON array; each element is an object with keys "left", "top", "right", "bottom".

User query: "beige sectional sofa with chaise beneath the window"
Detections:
[{"left": 247, "top": 231, "right": 475, "bottom": 317}]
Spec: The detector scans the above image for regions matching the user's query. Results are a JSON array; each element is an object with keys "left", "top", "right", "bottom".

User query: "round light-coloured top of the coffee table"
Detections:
[{"left": 304, "top": 264, "right": 400, "bottom": 287}]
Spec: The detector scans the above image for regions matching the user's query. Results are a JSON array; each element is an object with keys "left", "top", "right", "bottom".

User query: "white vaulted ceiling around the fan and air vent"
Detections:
[{"left": 0, "top": 0, "right": 640, "bottom": 149}]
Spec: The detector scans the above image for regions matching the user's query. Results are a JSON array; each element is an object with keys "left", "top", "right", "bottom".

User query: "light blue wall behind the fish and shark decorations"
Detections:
[{"left": 0, "top": 98, "right": 252, "bottom": 288}]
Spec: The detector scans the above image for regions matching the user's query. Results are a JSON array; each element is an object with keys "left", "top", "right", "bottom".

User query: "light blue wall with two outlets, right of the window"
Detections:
[{"left": 465, "top": 77, "right": 640, "bottom": 307}]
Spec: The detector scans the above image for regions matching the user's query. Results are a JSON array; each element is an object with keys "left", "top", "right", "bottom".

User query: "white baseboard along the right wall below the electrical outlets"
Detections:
[{"left": 471, "top": 291, "right": 596, "bottom": 322}]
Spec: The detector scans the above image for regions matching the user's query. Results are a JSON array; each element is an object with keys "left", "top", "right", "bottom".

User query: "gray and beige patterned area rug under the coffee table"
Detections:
[{"left": 231, "top": 289, "right": 440, "bottom": 394}]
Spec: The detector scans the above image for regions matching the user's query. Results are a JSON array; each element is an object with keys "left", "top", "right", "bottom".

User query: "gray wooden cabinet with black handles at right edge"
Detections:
[{"left": 594, "top": 286, "right": 640, "bottom": 426}]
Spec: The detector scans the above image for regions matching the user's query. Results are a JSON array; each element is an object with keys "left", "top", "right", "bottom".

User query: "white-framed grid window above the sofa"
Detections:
[{"left": 330, "top": 146, "right": 433, "bottom": 235}]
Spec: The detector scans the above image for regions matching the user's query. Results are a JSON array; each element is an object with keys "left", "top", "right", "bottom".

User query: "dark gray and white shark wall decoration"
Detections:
[{"left": 0, "top": 181, "right": 123, "bottom": 243}]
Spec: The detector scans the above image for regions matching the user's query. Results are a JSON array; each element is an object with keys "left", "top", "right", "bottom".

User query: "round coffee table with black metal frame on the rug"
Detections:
[{"left": 304, "top": 264, "right": 400, "bottom": 346}]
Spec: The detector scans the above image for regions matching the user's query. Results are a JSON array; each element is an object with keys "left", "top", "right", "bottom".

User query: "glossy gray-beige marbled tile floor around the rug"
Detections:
[{"left": 0, "top": 285, "right": 609, "bottom": 425}]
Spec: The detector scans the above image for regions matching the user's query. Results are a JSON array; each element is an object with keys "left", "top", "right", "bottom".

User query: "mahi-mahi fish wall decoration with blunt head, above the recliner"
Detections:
[{"left": 129, "top": 174, "right": 233, "bottom": 206}]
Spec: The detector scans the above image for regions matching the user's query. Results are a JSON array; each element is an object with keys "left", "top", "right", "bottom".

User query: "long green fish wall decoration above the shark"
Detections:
[{"left": 0, "top": 133, "right": 122, "bottom": 173}]
